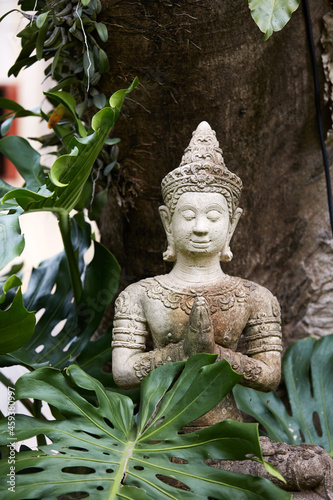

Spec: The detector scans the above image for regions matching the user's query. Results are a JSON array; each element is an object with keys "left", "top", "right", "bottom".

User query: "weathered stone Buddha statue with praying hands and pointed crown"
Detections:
[{"left": 112, "top": 122, "right": 281, "bottom": 425}]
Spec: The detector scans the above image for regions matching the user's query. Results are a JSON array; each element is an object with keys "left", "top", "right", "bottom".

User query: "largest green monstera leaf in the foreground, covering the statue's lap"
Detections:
[{"left": 0, "top": 354, "right": 291, "bottom": 500}]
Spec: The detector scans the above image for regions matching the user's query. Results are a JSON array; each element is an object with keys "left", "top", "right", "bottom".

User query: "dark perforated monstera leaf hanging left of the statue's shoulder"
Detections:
[{"left": 0, "top": 222, "right": 120, "bottom": 368}]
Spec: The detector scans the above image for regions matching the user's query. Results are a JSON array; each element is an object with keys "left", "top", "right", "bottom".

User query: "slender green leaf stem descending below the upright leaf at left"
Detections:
[{"left": 58, "top": 212, "right": 82, "bottom": 306}]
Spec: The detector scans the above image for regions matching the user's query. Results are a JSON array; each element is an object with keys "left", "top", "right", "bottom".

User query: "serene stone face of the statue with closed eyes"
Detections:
[{"left": 171, "top": 192, "right": 230, "bottom": 256}]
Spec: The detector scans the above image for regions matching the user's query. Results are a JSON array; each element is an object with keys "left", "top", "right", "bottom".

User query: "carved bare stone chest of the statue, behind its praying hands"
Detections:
[{"left": 143, "top": 278, "right": 251, "bottom": 349}]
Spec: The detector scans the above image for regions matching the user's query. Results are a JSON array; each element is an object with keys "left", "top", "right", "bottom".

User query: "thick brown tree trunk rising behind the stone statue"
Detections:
[{"left": 100, "top": 0, "right": 333, "bottom": 345}]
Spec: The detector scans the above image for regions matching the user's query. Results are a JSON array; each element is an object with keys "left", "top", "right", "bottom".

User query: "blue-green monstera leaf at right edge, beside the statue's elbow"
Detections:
[{"left": 234, "top": 335, "right": 333, "bottom": 456}]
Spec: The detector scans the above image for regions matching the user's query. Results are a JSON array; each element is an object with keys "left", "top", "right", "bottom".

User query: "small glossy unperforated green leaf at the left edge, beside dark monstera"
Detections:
[{"left": 0, "top": 275, "right": 36, "bottom": 354}]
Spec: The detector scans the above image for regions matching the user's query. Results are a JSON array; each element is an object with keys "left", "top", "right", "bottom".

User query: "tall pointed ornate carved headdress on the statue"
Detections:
[{"left": 161, "top": 122, "right": 242, "bottom": 214}]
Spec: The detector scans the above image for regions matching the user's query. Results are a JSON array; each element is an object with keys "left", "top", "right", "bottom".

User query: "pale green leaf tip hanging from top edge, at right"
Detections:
[{"left": 249, "top": 0, "right": 300, "bottom": 40}]
